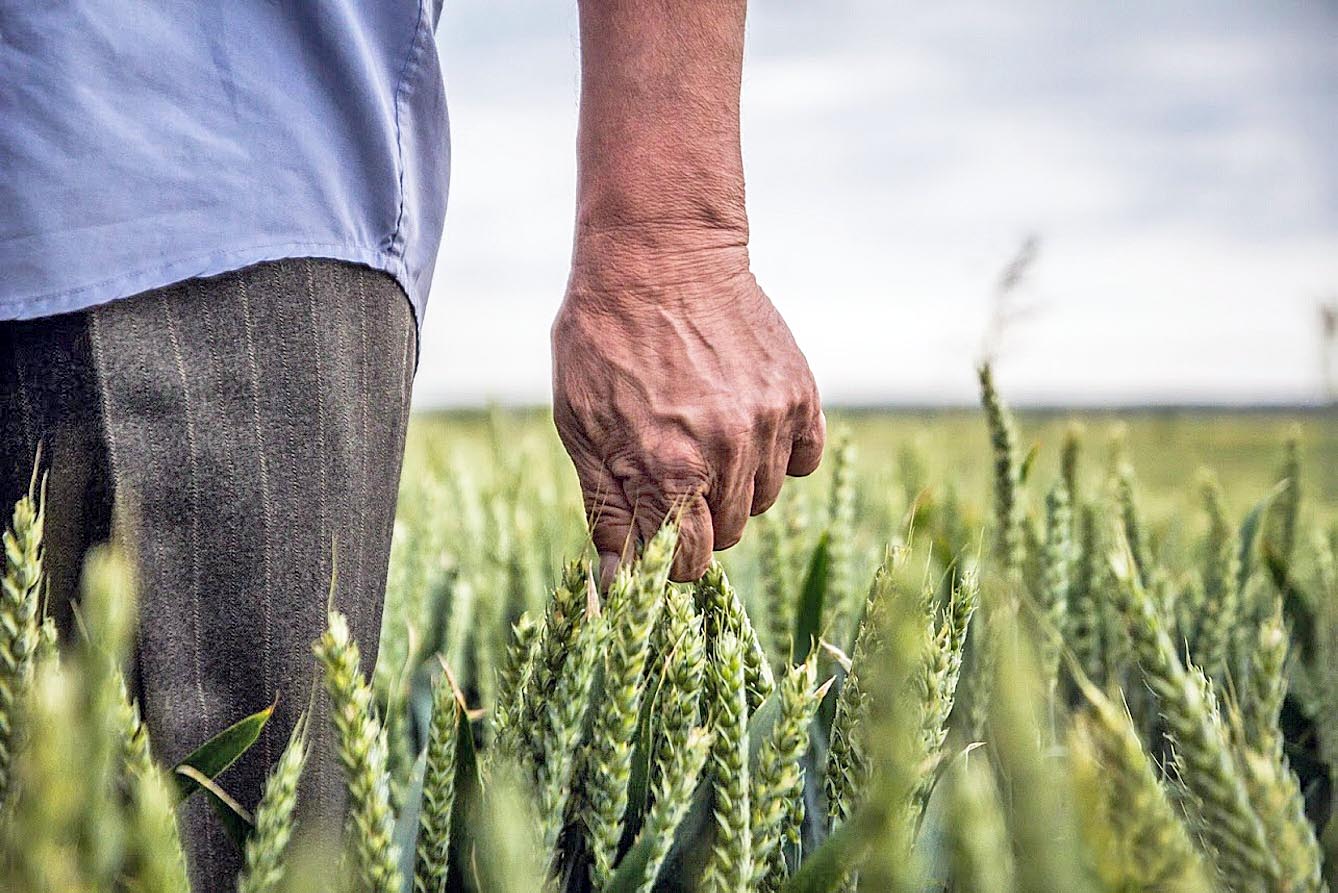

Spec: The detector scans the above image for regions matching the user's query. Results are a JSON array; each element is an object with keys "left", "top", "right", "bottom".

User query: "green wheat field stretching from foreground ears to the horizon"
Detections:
[{"left": 0, "top": 370, "right": 1338, "bottom": 893}]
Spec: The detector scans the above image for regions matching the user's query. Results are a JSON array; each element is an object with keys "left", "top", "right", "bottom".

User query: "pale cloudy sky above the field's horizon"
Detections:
[{"left": 415, "top": 0, "right": 1338, "bottom": 407}]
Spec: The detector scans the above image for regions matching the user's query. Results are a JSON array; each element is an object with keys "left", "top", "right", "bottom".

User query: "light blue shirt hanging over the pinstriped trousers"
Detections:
[{"left": 0, "top": 0, "right": 450, "bottom": 320}]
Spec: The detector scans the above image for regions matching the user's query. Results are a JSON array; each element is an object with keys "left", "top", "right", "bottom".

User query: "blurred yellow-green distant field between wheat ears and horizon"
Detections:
[{"left": 404, "top": 407, "right": 1338, "bottom": 551}]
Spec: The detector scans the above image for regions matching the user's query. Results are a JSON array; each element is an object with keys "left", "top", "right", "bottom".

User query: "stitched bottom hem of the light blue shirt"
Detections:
[{"left": 0, "top": 241, "right": 423, "bottom": 328}]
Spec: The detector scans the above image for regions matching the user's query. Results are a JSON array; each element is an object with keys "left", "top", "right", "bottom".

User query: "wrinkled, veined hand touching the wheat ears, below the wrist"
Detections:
[{"left": 553, "top": 227, "right": 826, "bottom": 584}]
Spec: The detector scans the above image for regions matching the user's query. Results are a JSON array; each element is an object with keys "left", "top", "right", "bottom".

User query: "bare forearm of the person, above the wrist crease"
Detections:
[{"left": 577, "top": 0, "right": 748, "bottom": 250}]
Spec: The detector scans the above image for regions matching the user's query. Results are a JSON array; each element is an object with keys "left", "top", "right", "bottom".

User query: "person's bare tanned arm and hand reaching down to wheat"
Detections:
[{"left": 553, "top": 0, "right": 826, "bottom": 582}]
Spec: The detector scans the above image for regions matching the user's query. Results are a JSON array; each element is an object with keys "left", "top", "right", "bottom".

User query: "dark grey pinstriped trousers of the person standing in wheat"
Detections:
[{"left": 0, "top": 258, "right": 416, "bottom": 893}]
